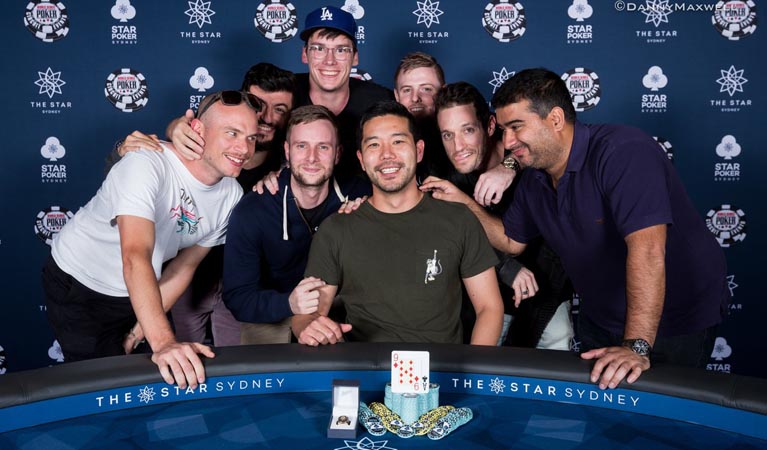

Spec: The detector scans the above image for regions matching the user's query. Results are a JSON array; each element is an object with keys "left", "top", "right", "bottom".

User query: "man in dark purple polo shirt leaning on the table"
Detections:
[{"left": 491, "top": 69, "right": 729, "bottom": 389}]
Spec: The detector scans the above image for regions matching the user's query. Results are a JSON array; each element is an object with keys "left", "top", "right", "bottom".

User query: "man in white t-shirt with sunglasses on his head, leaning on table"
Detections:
[{"left": 43, "top": 91, "right": 261, "bottom": 388}]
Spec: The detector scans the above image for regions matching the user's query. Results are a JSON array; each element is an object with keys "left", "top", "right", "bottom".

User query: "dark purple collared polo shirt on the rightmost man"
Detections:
[{"left": 503, "top": 122, "right": 729, "bottom": 336}]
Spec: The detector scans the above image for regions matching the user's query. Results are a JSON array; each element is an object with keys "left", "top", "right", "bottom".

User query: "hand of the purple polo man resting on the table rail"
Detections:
[{"left": 581, "top": 347, "right": 650, "bottom": 389}]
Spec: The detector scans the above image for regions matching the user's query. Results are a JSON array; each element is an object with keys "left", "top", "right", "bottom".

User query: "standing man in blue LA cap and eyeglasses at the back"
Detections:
[{"left": 295, "top": 6, "right": 392, "bottom": 178}]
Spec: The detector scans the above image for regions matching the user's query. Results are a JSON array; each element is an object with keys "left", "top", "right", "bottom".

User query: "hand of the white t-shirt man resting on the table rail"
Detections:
[{"left": 152, "top": 342, "right": 216, "bottom": 389}]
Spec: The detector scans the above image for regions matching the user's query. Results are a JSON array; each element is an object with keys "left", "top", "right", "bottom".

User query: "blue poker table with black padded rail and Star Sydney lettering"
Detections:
[{"left": 0, "top": 343, "right": 767, "bottom": 450}]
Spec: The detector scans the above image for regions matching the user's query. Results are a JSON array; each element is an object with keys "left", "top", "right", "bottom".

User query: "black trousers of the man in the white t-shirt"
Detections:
[{"left": 42, "top": 258, "right": 136, "bottom": 362}]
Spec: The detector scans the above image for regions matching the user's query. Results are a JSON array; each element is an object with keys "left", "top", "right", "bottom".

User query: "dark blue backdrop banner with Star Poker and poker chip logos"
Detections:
[{"left": 0, "top": 0, "right": 767, "bottom": 377}]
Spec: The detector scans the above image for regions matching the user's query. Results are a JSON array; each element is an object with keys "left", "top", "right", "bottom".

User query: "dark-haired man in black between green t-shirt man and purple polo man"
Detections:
[{"left": 421, "top": 81, "right": 573, "bottom": 350}]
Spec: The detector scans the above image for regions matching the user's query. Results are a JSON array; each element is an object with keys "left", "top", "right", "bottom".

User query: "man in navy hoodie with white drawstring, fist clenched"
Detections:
[{"left": 223, "top": 105, "right": 370, "bottom": 344}]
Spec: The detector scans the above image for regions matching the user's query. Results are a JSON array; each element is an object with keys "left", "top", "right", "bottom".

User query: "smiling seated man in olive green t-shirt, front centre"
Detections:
[{"left": 292, "top": 101, "right": 503, "bottom": 345}]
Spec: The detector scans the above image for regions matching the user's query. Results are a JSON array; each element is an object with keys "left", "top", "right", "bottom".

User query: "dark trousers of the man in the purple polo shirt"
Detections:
[{"left": 578, "top": 314, "right": 719, "bottom": 367}]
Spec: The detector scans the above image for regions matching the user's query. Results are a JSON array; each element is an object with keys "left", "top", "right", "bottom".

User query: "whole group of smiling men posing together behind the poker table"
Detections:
[{"left": 43, "top": 6, "right": 729, "bottom": 394}]
